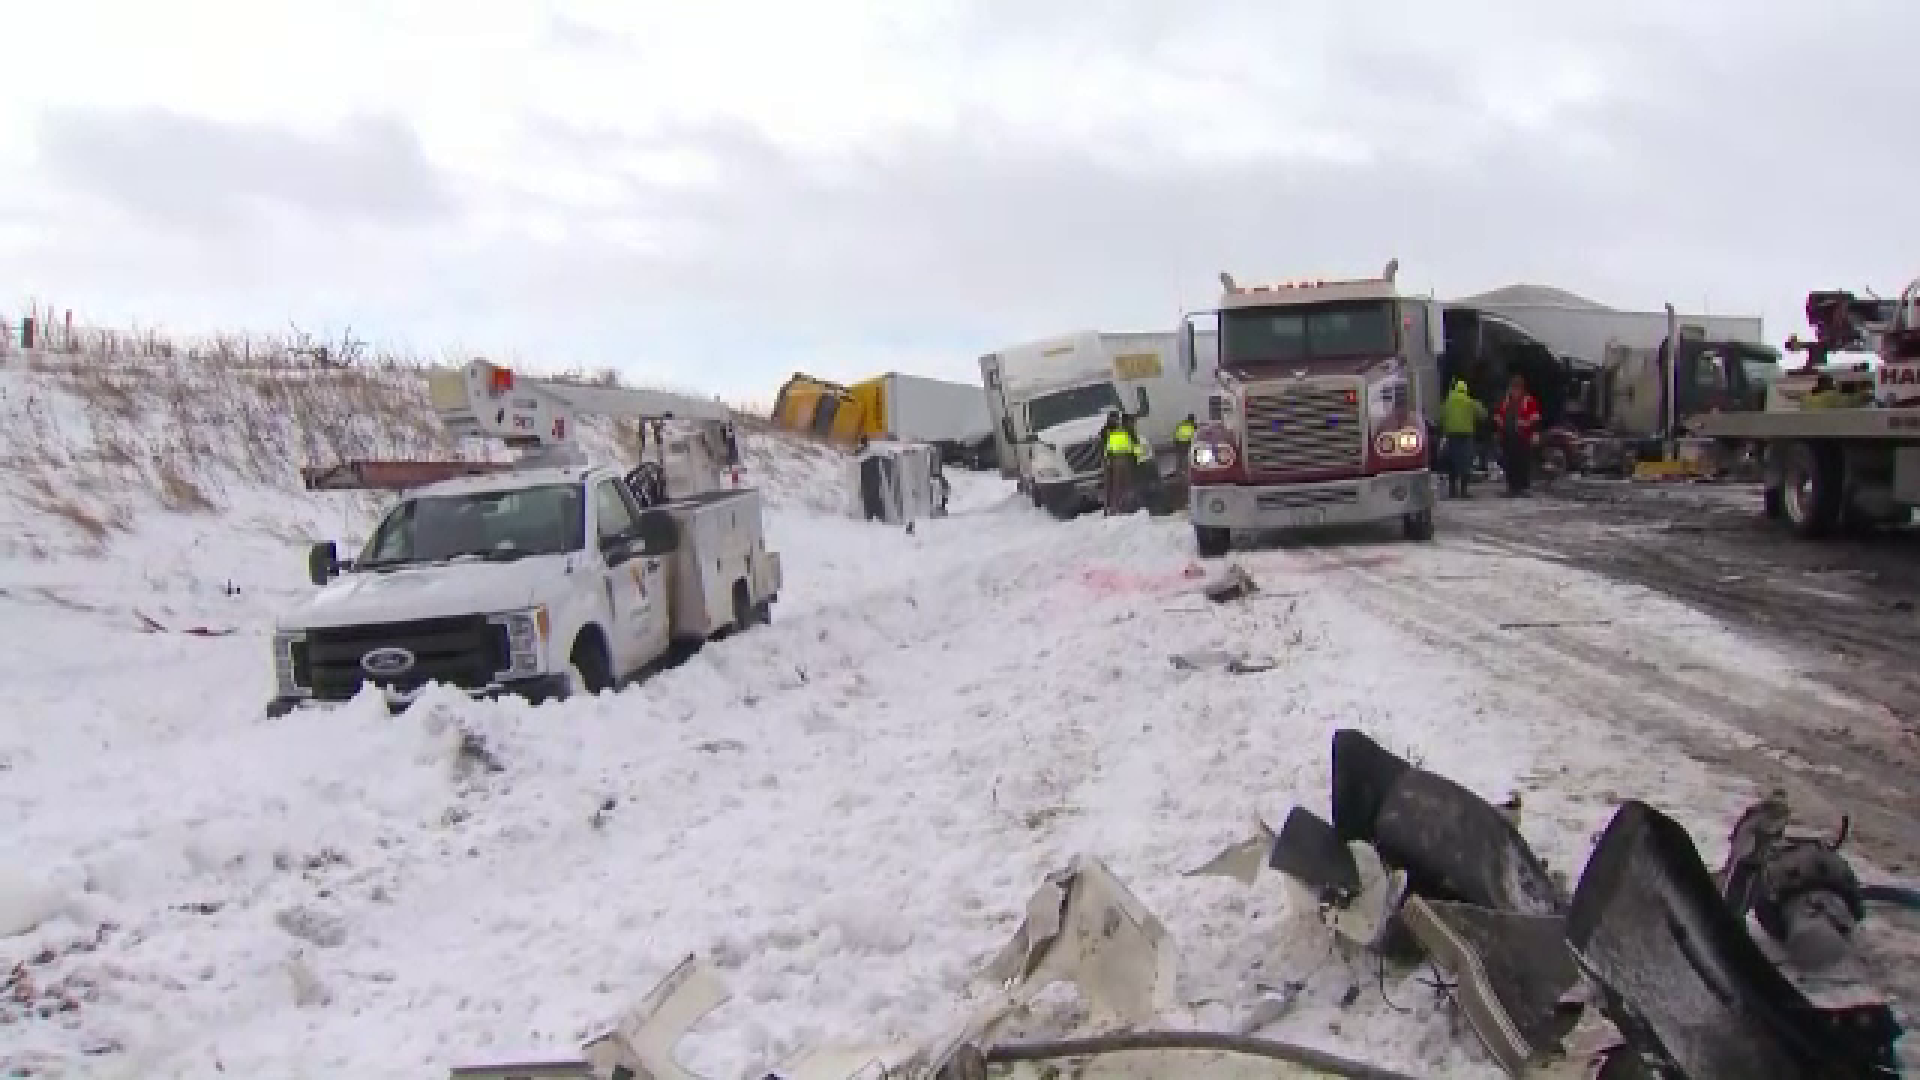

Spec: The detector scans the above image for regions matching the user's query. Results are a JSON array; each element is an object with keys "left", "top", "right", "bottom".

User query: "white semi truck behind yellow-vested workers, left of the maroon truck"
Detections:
[{"left": 979, "top": 331, "right": 1213, "bottom": 519}]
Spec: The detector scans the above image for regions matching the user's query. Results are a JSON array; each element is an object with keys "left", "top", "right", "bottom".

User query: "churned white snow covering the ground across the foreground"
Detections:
[{"left": 0, "top": 477, "right": 1896, "bottom": 1080}]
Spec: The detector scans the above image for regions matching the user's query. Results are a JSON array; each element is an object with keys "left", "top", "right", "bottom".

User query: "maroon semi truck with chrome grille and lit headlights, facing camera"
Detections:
[{"left": 1181, "top": 261, "right": 1444, "bottom": 559}]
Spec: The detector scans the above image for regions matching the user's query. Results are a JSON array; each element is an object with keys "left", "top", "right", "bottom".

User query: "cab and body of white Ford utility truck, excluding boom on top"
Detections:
[{"left": 267, "top": 469, "right": 781, "bottom": 715}]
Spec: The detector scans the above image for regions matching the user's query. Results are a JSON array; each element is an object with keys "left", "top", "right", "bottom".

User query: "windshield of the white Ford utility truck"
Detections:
[{"left": 357, "top": 484, "right": 586, "bottom": 569}]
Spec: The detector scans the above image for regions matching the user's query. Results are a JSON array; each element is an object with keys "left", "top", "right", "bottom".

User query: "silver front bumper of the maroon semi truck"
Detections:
[{"left": 1187, "top": 469, "right": 1434, "bottom": 532}]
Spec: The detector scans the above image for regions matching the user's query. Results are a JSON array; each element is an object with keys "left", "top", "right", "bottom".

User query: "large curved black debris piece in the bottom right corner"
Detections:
[{"left": 1567, "top": 801, "right": 1901, "bottom": 1080}]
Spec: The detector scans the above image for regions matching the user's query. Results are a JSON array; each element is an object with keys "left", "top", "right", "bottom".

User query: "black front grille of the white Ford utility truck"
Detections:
[{"left": 305, "top": 615, "right": 509, "bottom": 701}]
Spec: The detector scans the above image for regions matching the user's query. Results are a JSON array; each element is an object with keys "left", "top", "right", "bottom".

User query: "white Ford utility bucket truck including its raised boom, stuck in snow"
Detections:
[{"left": 267, "top": 361, "right": 781, "bottom": 715}]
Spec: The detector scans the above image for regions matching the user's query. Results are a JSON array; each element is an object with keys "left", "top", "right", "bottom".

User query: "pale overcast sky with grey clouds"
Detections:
[{"left": 0, "top": 0, "right": 1920, "bottom": 402}]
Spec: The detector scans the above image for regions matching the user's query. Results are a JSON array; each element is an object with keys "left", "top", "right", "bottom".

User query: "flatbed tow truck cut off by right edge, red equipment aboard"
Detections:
[{"left": 1688, "top": 279, "right": 1920, "bottom": 538}]
